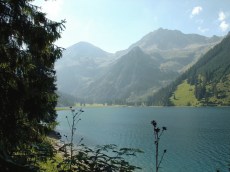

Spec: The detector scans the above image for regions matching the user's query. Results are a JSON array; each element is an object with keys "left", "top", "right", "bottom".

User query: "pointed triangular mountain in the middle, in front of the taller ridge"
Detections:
[{"left": 81, "top": 47, "right": 178, "bottom": 102}]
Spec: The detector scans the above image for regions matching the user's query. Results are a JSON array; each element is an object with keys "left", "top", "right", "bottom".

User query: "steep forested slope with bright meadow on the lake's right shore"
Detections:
[{"left": 148, "top": 34, "right": 230, "bottom": 106}]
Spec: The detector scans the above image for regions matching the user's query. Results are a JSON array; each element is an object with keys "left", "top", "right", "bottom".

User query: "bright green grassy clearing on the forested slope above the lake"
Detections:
[{"left": 170, "top": 80, "right": 201, "bottom": 106}]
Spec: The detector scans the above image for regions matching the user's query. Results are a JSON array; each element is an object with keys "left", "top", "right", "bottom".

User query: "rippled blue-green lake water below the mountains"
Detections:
[{"left": 57, "top": 107, "right": 230, "bottom": 172}]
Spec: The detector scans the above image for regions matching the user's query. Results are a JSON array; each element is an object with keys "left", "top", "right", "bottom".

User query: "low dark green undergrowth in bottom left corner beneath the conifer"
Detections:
[{"left": 0, "top": 139, "right": 56, "bottom": 172}]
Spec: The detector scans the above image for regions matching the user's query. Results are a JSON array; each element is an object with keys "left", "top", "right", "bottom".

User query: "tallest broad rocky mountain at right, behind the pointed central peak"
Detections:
[{"left": 117, "top": 28, "right": 222, "bottom": 73}]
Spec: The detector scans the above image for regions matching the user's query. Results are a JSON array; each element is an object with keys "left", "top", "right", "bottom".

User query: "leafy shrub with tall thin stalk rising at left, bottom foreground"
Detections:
[{"left": 57, "top": 107, "right": 142, "bottom": 172}]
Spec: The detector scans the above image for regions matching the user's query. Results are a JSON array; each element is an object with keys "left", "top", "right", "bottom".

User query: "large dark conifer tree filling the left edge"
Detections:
[{"left": 0, "top": 0, "right": 64, "bottom": 169}]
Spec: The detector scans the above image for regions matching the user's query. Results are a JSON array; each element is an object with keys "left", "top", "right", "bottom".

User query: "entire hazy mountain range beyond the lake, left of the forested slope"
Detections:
[{"left": 55, "top": 29, "right": 222, "bottom": 103}]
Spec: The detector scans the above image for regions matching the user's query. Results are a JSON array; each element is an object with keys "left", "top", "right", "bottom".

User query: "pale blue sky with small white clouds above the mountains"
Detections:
[{"left": 33, "top": 0, "right": 230, "bottom": 53}]
